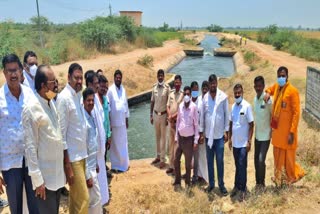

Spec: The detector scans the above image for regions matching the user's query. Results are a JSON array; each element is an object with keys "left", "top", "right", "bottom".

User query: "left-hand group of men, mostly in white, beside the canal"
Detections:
[{"left": 0, "top": 51, "right": 129, "bottom": 214}]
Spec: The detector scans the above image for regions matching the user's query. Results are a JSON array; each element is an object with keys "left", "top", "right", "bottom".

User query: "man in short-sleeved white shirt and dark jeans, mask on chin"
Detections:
[{"left": 229, "top": 84, "right": 253, "bottom": 201}]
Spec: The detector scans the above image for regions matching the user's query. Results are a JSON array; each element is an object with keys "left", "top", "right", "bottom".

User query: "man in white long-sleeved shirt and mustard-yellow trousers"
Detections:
[{"left": 57, "top": 63, "right": 89, "bottom": 214}]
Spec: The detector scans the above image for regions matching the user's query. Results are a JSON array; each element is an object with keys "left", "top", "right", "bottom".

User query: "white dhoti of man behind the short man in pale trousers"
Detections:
[{"left": 97, "top": 153, "right": 109, "bottom": 206}]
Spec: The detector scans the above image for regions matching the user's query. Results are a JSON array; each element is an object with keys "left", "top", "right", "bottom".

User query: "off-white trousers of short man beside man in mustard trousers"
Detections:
[{"left": 88, "top": 170, "right": 102, "bottom": 214}]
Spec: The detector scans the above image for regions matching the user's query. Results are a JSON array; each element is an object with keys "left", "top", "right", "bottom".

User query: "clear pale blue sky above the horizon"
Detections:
[{"left": 0, "top": 0, "right": 320, "bottom": 28}]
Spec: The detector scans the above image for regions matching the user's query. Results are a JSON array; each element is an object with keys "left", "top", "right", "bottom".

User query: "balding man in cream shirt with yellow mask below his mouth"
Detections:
[{"left": 22, "top": 65, "right": 66, "bottom": 214}]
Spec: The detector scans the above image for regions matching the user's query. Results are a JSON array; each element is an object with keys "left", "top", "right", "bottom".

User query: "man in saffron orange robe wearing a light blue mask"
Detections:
[{"left": 264, "top": 66, "right": 305, "bottom": 185}]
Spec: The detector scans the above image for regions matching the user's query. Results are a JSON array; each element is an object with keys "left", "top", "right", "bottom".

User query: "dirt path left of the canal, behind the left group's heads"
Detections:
[{"left": 53, "top": 40, "right": 183, "bottom": 96}]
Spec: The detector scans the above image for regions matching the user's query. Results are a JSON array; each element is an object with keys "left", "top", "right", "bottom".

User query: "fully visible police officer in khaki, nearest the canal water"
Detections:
[{"left": 150, "top": 69, "right": 170, "bottom": 169}]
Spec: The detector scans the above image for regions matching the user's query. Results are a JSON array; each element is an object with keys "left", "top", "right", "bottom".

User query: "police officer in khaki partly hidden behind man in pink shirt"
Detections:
[{"left": 166, "top": 75, "right": 183, "bottom": 173}]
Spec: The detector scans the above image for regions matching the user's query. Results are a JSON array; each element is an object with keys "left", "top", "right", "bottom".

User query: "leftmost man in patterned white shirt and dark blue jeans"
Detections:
[{"left": 0, "top": 54, "right": 39, "bottom": 214}]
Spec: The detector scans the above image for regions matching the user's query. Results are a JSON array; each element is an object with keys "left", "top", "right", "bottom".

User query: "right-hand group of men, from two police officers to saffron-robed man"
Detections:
[{"left": 150, "top": 66, "right": 305, "bottom": 200}]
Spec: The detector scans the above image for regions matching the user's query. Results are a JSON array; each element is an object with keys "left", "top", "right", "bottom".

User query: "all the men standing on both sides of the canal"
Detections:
[{"left": 0, "top": 48, "right": 304, "bottom": 214}]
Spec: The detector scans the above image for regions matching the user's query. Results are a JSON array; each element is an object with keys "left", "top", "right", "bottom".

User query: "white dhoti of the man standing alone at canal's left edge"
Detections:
[{"left": 109, "top": 125, "right": 129, "bottom": 171}]
